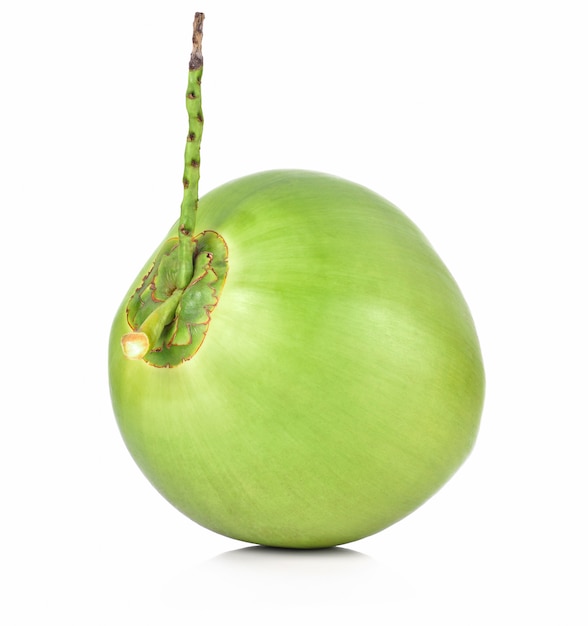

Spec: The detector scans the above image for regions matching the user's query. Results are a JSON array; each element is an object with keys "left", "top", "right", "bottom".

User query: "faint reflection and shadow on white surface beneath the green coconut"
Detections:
[{"left": 164, "top": 546, "right": 414, "bottom": 617}]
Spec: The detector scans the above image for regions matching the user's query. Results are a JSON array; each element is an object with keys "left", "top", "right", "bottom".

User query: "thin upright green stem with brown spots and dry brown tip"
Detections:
[{"left": 176, "top": 13, "right": 204, "bottom": 289}]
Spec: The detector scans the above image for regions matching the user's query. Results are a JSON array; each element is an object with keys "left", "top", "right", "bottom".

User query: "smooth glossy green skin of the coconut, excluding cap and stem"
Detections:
[{"left": 109, "top": 171, "right": 484, "bottom": 548}]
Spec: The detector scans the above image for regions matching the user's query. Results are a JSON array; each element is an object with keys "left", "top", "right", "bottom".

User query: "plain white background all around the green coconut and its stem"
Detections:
[{"left": 0, "top": 0, "right": 588, "bottom": 626}]
